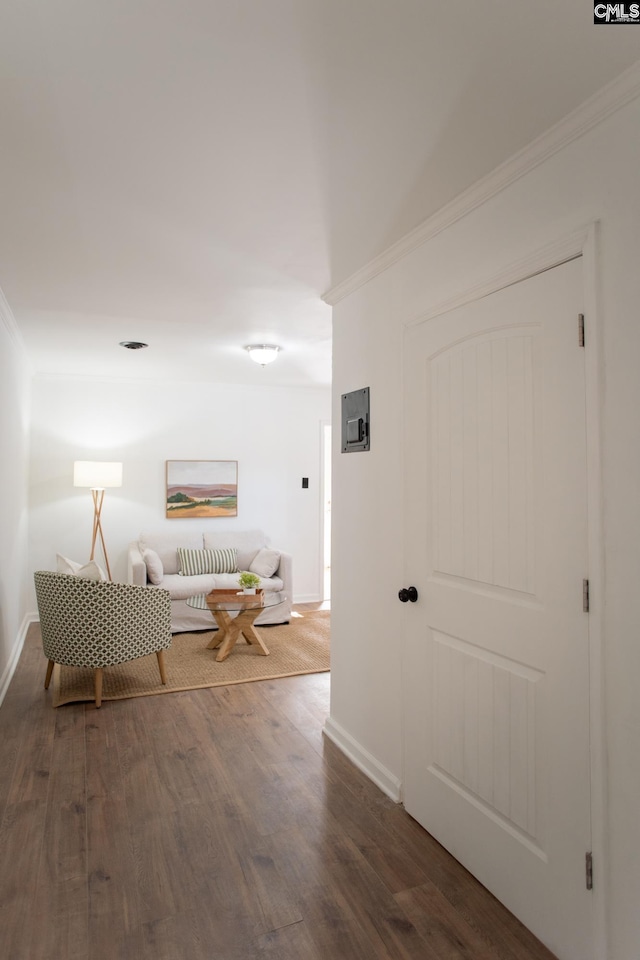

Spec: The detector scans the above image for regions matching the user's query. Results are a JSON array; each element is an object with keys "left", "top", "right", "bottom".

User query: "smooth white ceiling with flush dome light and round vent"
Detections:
[{"left": 0, "top": 0, "right": 640, "bottom": 386}]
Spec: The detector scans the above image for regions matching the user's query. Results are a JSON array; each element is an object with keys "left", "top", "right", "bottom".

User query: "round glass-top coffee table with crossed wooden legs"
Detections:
[{"left": 187, "top": 590, "right": 286, "bottom": 663}]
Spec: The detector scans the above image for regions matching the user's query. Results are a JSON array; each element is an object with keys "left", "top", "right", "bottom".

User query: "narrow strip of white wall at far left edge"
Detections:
[{"left": 0, "top": 291, "right": 30, "bottom": 702}]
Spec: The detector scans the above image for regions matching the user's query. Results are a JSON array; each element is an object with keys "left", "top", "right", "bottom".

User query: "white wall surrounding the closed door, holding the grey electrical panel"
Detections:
[{"left": 329, "top": 88, "right": 640, "bottom": 960}]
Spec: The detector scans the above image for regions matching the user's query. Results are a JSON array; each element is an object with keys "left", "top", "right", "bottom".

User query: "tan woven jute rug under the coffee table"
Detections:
[{"left": 51, "top": 610, "right": 331, "bottom": 707}]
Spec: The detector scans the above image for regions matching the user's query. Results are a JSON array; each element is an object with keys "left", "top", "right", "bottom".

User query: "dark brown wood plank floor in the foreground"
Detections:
[{"left": 0, "top": 627, "right": 551, "bottom": 960}]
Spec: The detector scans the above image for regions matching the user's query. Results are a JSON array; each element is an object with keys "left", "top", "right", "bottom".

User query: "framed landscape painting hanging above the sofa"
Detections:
[{"left": 167, "top": 460, "right": 238, "bottom": 519}]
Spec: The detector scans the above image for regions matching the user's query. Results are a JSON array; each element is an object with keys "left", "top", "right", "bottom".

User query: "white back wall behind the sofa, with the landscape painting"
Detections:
[{"left": 29, "top": 378, "right": 330, "bottom": 603}]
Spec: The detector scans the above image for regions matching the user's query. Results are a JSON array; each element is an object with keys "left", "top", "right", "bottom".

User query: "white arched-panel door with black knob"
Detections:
[{"left": 403, "top": 259, "right": 596, "bottom": 960}]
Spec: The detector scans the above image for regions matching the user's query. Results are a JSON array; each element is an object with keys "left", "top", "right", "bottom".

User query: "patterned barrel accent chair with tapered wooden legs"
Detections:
[{"left": 34, "top": 570, "right": 171, "bottom": 707}]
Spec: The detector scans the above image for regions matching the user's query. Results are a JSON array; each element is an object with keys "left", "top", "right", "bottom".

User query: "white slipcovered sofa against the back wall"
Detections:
[{"left": 127, "top": 530, "right": 293, "bottom": 633}]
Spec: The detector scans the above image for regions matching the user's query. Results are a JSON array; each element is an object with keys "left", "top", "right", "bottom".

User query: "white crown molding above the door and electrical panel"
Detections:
[{"left": 322, "top": 60, "right": 640, "bottom": 307}]
